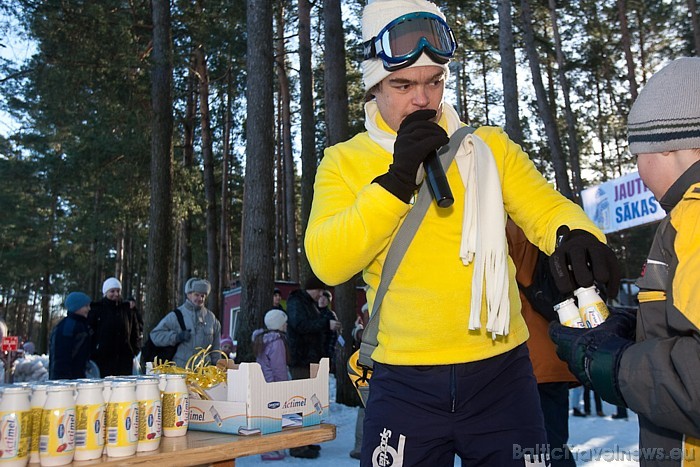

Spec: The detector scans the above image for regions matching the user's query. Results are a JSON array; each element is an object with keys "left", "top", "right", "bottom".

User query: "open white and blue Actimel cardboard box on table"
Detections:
[{"left": 189, "top": 358, "right": 329, "bottom": 435}]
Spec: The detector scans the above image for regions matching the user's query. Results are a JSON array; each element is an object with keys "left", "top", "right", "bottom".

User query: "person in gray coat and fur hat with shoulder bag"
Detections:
[{"left": 150, "top": 277, "right": 221, "bottom": 368}]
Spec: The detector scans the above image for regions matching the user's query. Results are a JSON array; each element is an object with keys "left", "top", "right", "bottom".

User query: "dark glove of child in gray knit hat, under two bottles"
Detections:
[{"left": 549, "top": 311, "right": 637, "bottom": 406}]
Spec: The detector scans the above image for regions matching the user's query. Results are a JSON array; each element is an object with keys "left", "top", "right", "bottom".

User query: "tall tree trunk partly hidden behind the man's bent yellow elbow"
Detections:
[{"left": 323, "top": 0, "right": 358, "bottom": 405}]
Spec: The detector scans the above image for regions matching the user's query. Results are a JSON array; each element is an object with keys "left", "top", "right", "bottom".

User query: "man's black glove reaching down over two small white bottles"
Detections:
[{"left": 549, "top": 226, "right": 620, "bottom": 298}]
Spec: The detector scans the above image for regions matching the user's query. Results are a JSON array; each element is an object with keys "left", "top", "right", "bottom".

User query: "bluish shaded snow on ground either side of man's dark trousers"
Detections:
[{"left": 236, "top": 375, "right": 639, "bottom": 467}]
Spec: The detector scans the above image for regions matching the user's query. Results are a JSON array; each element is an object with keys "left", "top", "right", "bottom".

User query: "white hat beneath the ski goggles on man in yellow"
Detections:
[{"left": 362, "top": 0, "right": 449, "bottom": 91}]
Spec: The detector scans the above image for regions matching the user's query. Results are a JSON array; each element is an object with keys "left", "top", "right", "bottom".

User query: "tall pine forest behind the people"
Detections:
[{"left": 0, "top": 0, "right": 700, "bottom": 403}]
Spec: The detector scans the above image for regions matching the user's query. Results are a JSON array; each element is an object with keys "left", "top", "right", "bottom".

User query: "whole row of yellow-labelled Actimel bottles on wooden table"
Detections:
[{"left": 0, "top": 374, "right": 189, "bottom": 467}]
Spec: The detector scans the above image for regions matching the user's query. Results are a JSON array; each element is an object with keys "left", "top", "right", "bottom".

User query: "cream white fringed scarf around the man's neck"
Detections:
[{"left": 365, "top": 101, "right": 510, "bottom": 339}]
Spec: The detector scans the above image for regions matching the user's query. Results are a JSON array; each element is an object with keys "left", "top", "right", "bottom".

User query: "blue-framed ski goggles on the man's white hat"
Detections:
[{"left": 362, "top": 12, "right": 457, "bottom": 71}]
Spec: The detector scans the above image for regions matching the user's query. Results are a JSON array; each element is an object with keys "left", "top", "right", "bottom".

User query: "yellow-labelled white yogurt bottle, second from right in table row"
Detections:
[{"left": 136, "top": 376, "right": 162, "bottom": 452}]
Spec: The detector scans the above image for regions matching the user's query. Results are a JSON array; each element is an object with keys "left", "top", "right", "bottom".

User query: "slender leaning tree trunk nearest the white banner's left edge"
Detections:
[{"left": 549, "top": 0, "right": 583, "bottom": 204}]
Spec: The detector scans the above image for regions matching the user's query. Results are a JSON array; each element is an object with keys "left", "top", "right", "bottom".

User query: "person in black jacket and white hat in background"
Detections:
[{"left": 89, "top": 277, "right": 141, "bottom": 378}]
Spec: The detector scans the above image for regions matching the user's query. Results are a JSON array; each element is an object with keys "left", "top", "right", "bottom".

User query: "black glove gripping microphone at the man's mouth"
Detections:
[{"left": 373, "top": 109, "right": 450, "bottom": 203}]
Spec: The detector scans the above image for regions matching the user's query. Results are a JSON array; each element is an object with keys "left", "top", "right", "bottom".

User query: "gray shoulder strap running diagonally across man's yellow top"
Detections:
[{"left": 359, "top": 126, "right": 474, "bottom": 368}]
